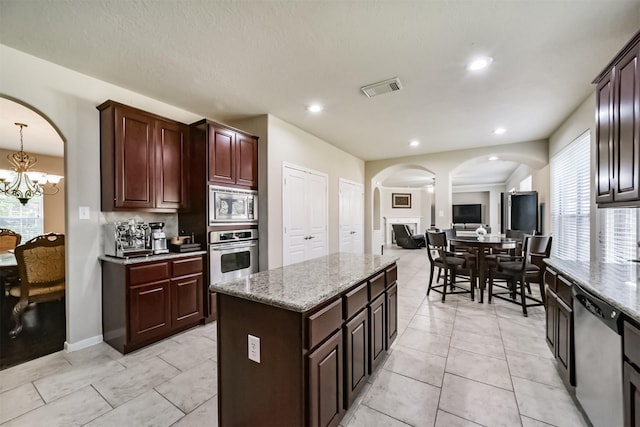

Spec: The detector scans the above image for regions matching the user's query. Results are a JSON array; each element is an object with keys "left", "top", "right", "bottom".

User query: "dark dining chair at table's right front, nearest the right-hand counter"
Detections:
[{"left": 489, "top": 234, "right": 552, "bottom": 317}]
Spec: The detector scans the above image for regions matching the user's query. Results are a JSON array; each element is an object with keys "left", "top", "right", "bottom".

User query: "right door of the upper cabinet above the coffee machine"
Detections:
[{"left": 156, "top": 120, "right": 188, "bottom": 209}]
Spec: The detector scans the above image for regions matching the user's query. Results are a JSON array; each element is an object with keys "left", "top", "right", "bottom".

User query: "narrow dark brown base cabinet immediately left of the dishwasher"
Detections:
[{"left": 545, "top": 267, "right": 576, "bottom": 386}]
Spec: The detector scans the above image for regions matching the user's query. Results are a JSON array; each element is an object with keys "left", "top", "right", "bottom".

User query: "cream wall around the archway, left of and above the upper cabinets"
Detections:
[{"left": 0, "top": 45, "right": 201, "bottom": 350}]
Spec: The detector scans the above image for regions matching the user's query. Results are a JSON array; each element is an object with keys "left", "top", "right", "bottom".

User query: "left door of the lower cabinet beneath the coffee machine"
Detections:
[{"left": 129, "top": 280, "right": 171, "bottom": 343}]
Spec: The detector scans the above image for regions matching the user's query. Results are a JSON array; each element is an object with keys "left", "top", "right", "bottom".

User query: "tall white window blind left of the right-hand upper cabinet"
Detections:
[{"left": 550, "top": 131, "right": 591, "bottom": 261}]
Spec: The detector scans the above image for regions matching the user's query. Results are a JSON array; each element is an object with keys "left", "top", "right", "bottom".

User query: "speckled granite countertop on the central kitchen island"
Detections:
[{"left": 209, "top": 253, "right": 398, "bottom": 312}]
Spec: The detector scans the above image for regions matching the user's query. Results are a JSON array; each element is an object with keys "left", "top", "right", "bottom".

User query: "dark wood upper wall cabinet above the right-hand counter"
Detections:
[{"left": 593, "top": 32, "right": 640, "bottom": 207}]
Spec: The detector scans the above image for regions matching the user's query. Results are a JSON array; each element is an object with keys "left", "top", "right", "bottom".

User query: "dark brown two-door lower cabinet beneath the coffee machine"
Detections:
[{"left": 102, "top": 255, "right": 203, "bottom": 353}]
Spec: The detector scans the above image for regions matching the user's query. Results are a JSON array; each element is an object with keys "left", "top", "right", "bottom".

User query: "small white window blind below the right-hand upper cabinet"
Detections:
[{"left": 598, "top": 208, "right": 639, "bottom": 263}]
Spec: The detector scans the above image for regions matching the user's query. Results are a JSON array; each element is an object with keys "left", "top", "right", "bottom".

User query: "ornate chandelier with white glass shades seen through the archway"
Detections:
[{"left": 0, "top": 123, "right": 62, "bottom": 205}]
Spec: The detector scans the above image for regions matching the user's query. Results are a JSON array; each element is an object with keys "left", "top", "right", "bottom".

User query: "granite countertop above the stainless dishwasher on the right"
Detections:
[{"left": 545, "top": 258, "right": 640, "bottom": 323}]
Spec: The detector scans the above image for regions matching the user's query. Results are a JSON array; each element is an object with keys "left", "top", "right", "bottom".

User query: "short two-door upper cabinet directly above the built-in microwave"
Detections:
[{"left": 191, "top": 120, "right": 258, "bottom": 189}]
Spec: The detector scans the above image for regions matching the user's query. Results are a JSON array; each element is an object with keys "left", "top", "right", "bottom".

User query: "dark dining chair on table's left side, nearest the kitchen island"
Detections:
[{"left": 425, "top": 230, "right": 476, "bottom": 302}]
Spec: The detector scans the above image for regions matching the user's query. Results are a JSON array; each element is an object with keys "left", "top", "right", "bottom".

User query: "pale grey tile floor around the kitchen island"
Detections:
[{"left": 0, "top": 249, "right": 588, "bottom": 427}]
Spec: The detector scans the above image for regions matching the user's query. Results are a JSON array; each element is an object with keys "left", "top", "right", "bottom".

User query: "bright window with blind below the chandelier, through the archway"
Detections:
[{"left": 0, "top": 193, "right": 44, "bottom": 243}]
